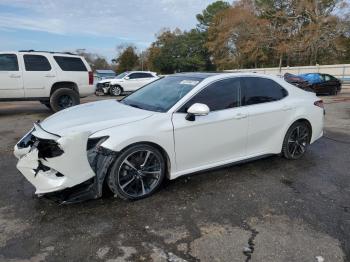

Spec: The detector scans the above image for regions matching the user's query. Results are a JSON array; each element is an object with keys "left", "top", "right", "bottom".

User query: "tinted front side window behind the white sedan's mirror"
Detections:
[{"left": 179, "top": 78, "right": 240, "bottom": 113}]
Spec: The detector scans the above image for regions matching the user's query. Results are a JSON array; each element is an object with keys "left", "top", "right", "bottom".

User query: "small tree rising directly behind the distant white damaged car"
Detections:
[{"left": 114, "top": 45, "right": 139, "bottom": 73}]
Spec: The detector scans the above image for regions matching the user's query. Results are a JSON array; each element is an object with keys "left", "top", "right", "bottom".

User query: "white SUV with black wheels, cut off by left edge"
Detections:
[{"left": 0, "top": 50, "right": 94, "bottom": 112}]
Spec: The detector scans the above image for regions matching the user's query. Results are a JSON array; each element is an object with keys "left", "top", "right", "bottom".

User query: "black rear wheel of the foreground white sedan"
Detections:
[{"left": 282, "top": 121, "right": 311, "bottom": 160}]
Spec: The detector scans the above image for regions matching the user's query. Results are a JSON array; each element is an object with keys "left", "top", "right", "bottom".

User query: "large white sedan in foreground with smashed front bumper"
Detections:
[{"left": 15, "top": 73, "right": 324, "bottom": 202}]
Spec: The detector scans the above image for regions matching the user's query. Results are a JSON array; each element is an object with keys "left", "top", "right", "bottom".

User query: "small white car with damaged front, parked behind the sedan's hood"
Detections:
[{"left": 96, "top": 71, "right": 159, "bottom": 96}]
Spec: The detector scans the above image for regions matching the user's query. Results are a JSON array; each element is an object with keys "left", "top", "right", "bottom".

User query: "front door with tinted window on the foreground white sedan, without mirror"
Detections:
[{"left": 172, "top": 78, "right": 248, "bottom": 173}]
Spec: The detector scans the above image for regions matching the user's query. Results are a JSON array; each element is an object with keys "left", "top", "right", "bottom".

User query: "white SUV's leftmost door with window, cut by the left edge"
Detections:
[{"left": 0, "top": 53, "right": 24, "bottom": 98}]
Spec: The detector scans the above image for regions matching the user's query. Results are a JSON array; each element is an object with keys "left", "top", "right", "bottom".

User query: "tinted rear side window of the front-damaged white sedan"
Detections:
[{"left": 241, "top": 77, "right": 287, "bottom": 105}]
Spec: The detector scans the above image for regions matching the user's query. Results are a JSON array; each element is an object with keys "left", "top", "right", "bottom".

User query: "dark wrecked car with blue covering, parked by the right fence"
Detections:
[{"left": 284, "top": 73, "right": 341, "bottom": 95}]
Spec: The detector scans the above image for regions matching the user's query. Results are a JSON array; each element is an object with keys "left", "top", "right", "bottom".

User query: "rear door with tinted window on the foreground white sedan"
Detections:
[{"left": 241, "top": 77, "right": 294, "bottom": 156}]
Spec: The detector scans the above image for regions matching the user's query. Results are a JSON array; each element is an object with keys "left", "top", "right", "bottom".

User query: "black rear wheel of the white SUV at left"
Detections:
[{"left": 50, "top": 88, "right": 80, "bottom": 112}]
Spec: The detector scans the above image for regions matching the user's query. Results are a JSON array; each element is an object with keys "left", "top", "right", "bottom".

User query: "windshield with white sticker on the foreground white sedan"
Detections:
[{"left": 121, "top": 76, "right": 201, "bottom": 112}]
